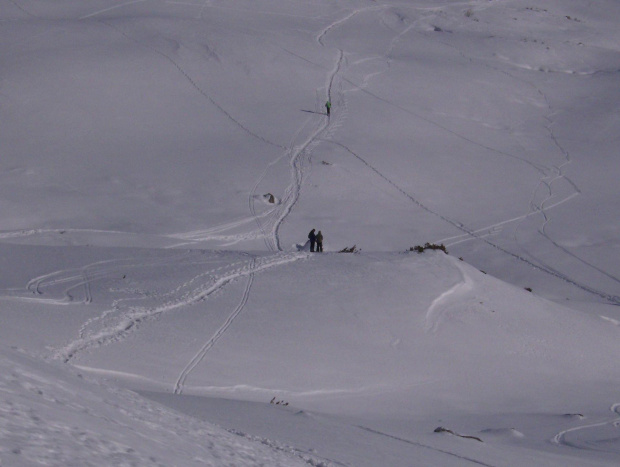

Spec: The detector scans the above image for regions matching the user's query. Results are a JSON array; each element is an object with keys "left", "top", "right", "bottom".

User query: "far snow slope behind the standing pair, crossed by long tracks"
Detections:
[{"left": 0, "top": 0, "right": 620, "bottom": 306}]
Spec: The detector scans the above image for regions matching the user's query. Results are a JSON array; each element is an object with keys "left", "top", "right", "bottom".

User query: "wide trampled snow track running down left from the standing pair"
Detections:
[{"left": 53, "top": 253, "right": 309, "bottom": 363}]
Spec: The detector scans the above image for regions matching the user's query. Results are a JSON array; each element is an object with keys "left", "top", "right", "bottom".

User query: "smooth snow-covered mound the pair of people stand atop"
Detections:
[{"left": 2, "top": 245, "right": 620, "bottom": 466}]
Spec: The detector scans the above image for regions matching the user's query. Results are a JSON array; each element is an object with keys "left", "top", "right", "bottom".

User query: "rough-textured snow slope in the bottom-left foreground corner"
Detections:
[{"left": 0, "top": 346, "right": 307, "bottom": 466}]
